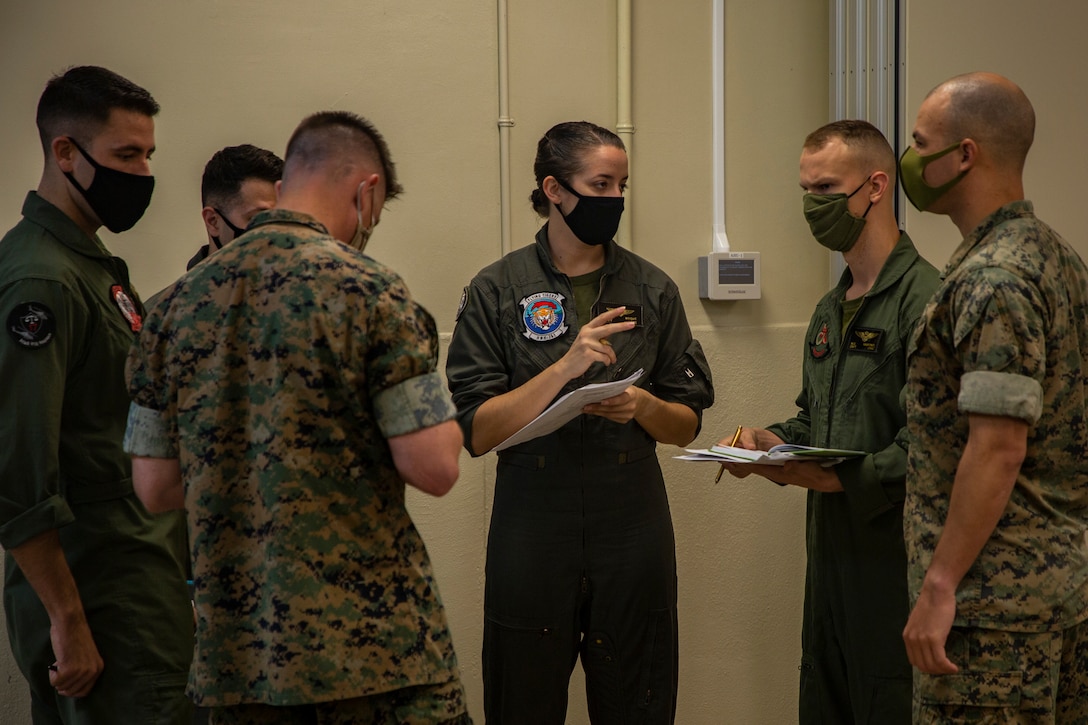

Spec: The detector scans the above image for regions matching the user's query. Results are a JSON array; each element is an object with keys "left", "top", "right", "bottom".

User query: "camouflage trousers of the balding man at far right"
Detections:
[{"left": 914, "top": 622, "right": 1088, "bottom": 725}]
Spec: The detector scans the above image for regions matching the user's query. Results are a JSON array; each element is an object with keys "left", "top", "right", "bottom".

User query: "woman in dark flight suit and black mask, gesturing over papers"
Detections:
[{"left": 446, "top": 122, "right": 714, "bottom": 725}]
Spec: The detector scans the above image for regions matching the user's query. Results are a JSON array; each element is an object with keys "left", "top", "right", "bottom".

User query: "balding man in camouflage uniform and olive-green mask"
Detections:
[{"left": 900, "top": 73, "right": 1088, "bottom": 723}]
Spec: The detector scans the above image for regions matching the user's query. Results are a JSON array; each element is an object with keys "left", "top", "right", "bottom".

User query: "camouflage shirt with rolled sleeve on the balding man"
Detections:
[{"left": 904, "top": 201, "right": 1088, "bottom": 631}]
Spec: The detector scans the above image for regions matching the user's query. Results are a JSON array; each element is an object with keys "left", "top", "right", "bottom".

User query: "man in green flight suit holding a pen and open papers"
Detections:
[{"left": 724, "top": 121, "right": 938, "bottom": 725}]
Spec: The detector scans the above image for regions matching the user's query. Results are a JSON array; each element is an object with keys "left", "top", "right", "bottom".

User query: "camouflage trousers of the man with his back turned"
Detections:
[{"left": 211, "top": 679, "right": 472, "bottom": 725}]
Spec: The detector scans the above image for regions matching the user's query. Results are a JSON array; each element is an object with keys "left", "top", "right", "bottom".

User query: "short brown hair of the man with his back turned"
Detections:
[{"left": 284, "top": 111, "right": 404, "bottom": 199}]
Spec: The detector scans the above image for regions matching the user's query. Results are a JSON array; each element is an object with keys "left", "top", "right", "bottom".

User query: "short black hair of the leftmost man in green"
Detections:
[{"left": 36, "top": 65, "right": 159, "bottom": 157}]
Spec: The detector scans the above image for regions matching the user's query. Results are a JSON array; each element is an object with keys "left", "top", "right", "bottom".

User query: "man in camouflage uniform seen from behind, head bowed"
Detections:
[{"left": 126, "top": 112, "right": 468, "bottom": 725}]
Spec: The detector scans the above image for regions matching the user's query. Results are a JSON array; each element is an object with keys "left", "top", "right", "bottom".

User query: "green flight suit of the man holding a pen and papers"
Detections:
[{"left": 768, "top": 233, "right": 938, "bottom": 725}]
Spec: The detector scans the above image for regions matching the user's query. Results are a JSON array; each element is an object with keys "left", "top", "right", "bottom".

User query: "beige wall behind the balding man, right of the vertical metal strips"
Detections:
[{"left": 905, "top": 0, "right": 1088, "bottom": 268}]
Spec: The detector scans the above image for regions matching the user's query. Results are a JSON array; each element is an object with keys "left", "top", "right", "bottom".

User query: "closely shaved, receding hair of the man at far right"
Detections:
[{"left": 926, "top": 73, "right": 1035, "bottom": 170}]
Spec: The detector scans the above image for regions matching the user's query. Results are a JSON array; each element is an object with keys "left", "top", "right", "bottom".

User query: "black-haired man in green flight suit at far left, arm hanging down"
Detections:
[{"left": 0, "top": 66, "right": 193, "bottom": 724}]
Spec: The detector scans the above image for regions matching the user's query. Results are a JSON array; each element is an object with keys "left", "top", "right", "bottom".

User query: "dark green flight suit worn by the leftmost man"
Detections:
[{"left": 0, "top": 193, "right": 193, "bottom": 725}]
